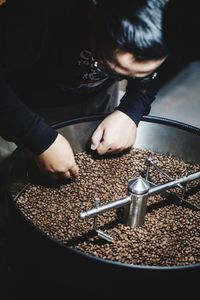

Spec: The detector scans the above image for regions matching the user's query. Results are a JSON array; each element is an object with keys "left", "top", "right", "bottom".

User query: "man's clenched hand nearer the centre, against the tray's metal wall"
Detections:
[{"left": 91, "top": 110, "right": 137, "bottom": 155}]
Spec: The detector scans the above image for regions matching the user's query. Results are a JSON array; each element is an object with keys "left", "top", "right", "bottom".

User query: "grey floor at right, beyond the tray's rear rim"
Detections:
[{"left": 150, "top": 61, "right": 200, "bottom": 128}]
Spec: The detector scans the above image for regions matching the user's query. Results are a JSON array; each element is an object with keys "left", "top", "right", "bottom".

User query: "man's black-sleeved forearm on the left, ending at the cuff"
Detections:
[{"left": 0, "top": 80, "right": 57, "bottom": 155}]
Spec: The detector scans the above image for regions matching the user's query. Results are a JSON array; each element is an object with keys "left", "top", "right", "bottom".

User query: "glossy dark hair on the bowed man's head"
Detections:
[{"left": 91, "top": 0, "right": 168, "bottom": 61}]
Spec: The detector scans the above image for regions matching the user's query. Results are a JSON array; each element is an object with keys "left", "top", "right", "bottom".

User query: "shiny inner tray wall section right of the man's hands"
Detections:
[{"left": 134, "top": 119, "right": 200, "bottom": 163}]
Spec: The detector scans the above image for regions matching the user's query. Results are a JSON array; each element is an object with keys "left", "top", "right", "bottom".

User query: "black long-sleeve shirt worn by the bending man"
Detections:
[{"left": 0, "top": 0, "right": 171, "bottom": 154}]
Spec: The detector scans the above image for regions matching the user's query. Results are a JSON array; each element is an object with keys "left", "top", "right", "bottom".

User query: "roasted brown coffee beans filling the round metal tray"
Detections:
[{"left": 16, "top": 148, "right": 200, "bottom": 266}]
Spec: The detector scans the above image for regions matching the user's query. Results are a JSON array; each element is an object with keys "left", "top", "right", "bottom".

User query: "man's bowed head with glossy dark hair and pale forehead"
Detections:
[{"left": 91, "top": 0, "right": 168, "bottom": 77}]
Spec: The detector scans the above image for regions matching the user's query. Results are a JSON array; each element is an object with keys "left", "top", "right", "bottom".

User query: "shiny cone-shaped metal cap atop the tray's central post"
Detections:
[{"left": 128, "top": 176, "right": 150, "bottom": 195}]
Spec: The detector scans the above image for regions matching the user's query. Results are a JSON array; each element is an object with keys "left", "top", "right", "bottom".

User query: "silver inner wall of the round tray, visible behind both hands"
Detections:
[{"left": 56, "top": 116, "right": 200, "bottom": 163}]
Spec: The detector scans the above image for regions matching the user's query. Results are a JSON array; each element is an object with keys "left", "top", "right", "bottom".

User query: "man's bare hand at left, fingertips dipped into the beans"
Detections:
[{"left": 36, "top": 134, "right": 78, "bottom": 179}]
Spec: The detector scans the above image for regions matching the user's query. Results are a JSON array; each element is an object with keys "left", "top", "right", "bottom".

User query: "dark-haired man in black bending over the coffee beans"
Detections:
[{"left": 0, "top": 0, "right": 168, "bottom": 178}]
